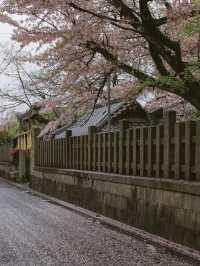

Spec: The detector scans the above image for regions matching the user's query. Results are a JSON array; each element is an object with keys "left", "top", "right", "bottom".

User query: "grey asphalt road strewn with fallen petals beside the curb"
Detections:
[{"left": 0, "top": 180, "right": 197, "bottom": 266}]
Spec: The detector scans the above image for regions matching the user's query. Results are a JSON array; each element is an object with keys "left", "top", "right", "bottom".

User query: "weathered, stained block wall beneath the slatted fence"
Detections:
[{"left": 31, "top": 168, "right": 200, "bottom": 250}]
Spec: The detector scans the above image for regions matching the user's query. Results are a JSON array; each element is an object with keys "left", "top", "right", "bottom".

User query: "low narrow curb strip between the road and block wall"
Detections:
[{"left": 0, "top": 177, "right": 200, "bottom": 265}]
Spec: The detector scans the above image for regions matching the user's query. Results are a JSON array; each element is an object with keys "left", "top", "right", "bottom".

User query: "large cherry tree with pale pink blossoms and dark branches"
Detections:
[{"left": 1, "top": 0, "right": 200, "bottom": 112}]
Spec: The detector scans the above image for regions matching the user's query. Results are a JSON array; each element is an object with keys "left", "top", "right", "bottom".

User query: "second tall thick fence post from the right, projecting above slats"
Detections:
[{"left": 119, "top": 119, "right": 128, "bottom": 174}]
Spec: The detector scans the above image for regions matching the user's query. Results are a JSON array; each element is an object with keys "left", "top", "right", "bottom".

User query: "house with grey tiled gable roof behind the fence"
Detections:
[{"left": 53, "top": 98, "right": 160, "bottom": 139}]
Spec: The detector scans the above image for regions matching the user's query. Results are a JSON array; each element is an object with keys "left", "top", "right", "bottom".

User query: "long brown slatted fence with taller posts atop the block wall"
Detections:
[{"left": 35, "top": 112, "right": 200, "bottom": 181}]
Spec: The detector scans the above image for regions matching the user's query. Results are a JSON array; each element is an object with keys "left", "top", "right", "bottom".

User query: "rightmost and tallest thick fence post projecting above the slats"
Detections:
[{"left": 164, "top": 111, "right": 176, "bottom": 178}]
